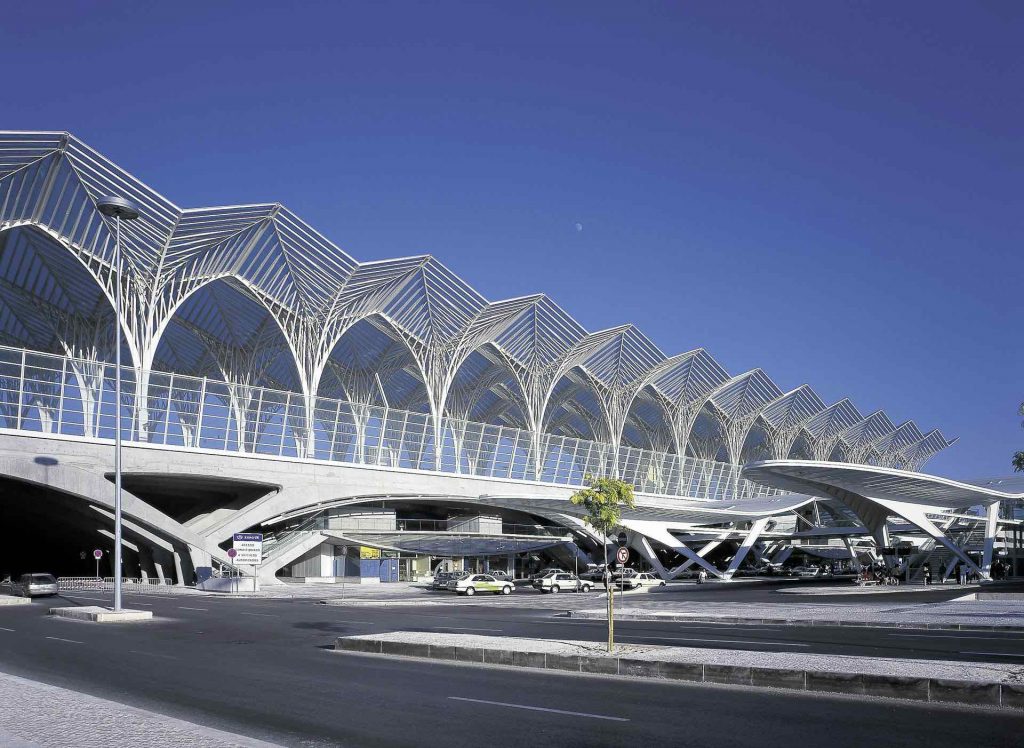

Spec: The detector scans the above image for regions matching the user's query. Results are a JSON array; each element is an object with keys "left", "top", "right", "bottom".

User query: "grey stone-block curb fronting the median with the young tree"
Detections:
[{"left": 334, "top": 636, "right": 1024, "bottom": 709}]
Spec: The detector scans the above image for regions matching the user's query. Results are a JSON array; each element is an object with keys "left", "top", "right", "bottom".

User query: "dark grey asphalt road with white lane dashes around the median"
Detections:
[{"left": 0, "top": 594, "right": 1024, "bottom": 748}]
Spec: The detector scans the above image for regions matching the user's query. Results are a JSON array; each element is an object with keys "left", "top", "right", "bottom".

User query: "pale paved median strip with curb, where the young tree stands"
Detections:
[{"left": 335, "top": 631, "right": 1024, "bottom": 709}]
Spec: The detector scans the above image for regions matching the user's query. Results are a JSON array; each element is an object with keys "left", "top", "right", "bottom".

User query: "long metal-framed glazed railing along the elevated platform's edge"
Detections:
[{"left": 0, "top": 346, "right": 779, "bottom": 500}]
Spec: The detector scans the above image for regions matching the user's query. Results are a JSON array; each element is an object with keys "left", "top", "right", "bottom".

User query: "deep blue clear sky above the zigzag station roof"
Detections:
[{"left": 0, "top": 0, "right": 1024, "bottom": 477}]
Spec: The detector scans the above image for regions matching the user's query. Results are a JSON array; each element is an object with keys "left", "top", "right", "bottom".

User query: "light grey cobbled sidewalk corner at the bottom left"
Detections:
[{"left": 0, "top": 673, "right": 280, "bottom": 748}]
